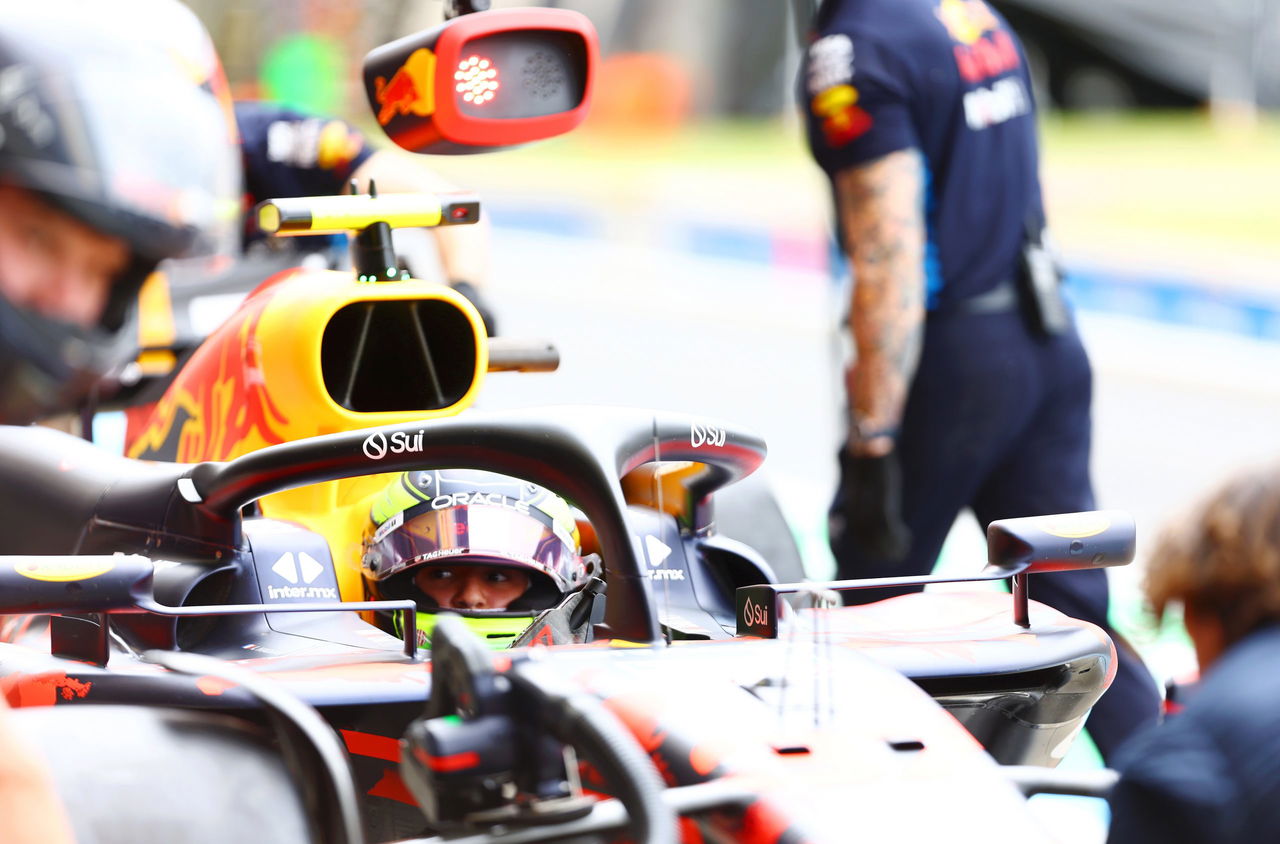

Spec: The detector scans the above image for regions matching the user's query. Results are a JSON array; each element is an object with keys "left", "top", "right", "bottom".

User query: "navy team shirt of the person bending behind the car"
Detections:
[{"left": 234, "top": 100, "right": 374, "bottom": 243}]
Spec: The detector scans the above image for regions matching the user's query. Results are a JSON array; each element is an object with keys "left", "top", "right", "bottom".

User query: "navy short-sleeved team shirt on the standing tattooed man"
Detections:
[{"left": 800, "top": 0, "right": 1043, "bottom": 309}]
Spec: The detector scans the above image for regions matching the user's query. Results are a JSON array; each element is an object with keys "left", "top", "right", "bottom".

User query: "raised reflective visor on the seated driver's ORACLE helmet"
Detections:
[{"left": 366, "top": 504, "right": 579, "bottom": 592}]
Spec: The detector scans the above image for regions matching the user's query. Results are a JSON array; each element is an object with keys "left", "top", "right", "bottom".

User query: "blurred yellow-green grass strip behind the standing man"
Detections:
[{"left": 417, "top": 111, "right": 1280, "bottom": 262}]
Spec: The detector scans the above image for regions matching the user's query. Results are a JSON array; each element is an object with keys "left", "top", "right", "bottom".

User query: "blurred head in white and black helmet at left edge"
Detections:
[{"left": 0, "top": 0, "right": 239, "bottom": 424}]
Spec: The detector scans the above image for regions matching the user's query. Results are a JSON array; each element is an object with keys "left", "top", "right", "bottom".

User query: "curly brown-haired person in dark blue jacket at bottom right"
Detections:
[{"left": 1108, "top": 465, "right": 1280, "bottom": 844}]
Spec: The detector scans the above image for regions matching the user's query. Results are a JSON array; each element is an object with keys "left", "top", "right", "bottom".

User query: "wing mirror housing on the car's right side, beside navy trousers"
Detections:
[{"left": 987, "top": 510, "right": 1137, "bottom": 574}]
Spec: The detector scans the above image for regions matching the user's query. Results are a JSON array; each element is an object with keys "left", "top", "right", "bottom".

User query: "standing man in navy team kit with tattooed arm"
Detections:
[{"left": 800, "top": 0, "right": 1160, "bottom": 759}]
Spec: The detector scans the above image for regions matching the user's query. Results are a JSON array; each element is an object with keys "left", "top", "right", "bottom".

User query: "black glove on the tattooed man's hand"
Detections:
[{"left": 832, "top": 448, "right": 911, "bottom": 562}]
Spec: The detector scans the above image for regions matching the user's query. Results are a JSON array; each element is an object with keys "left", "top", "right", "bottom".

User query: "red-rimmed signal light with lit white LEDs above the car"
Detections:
[{"left": 364, "top": 9, "right": 599, "bottom": 154}]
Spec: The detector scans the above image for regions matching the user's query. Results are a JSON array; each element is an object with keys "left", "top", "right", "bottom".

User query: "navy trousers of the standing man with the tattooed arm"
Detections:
[{"left": 832, "top": 311, "right": 1161, "bottom": 759}]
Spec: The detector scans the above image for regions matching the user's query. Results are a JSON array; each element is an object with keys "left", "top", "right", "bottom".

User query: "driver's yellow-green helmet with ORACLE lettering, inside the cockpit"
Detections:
[{"left": 362, "top": 469, "right": 595, "bottom": 648}]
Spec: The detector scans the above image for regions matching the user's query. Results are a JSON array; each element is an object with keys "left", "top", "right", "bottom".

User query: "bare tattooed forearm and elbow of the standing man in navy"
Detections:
[{"left": 835, "top": 150, "right": 924, "bottom": 456}]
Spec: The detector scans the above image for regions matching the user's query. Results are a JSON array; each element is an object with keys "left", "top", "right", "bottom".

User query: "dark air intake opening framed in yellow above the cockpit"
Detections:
[{"left": 320, "top": 300, "right": 476, "bottom": 414}]
